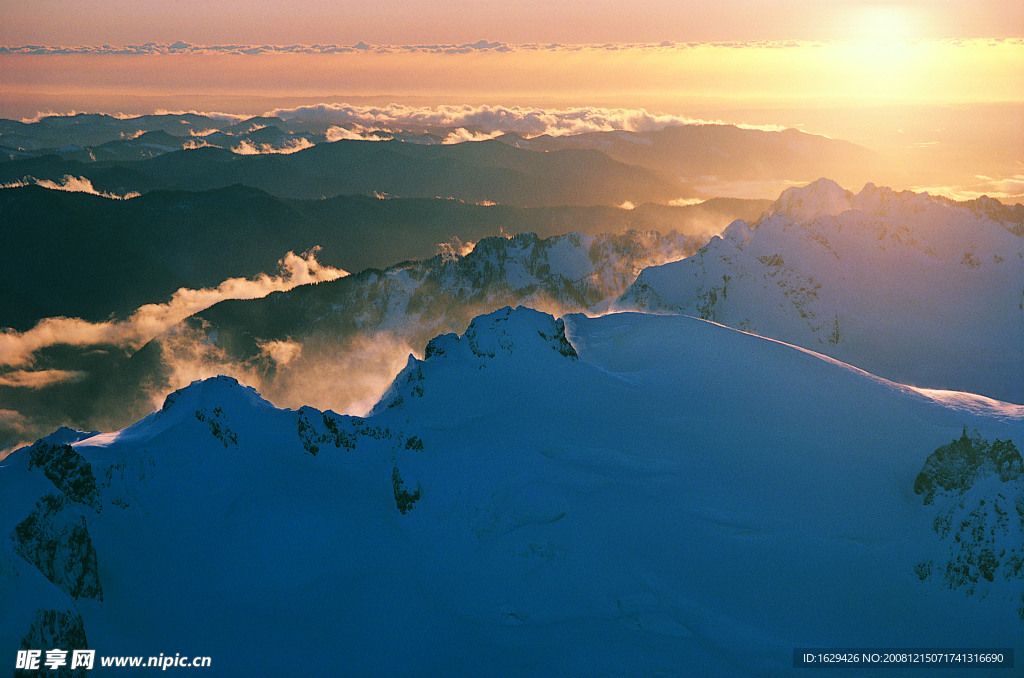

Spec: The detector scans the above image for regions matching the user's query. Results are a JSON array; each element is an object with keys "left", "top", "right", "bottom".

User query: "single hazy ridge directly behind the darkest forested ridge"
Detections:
[{"left": 0, "top": 139, "right": 697, "bottom": 207}]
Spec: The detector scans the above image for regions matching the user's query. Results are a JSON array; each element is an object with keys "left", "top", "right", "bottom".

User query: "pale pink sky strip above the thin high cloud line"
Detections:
[{"left": 6, "top": 0, "right": 1024, "bottom": 46}]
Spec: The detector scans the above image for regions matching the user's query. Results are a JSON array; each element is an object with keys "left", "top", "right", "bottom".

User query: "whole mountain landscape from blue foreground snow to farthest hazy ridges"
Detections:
[{"left": 0, "top": 140, "right": 1024, "bottom": 676}]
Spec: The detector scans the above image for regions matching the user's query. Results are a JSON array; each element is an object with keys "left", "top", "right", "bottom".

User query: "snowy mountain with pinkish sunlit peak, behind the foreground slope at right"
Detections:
[{"left": 615, "top": 179, "right": 1024, "bottom": 402}]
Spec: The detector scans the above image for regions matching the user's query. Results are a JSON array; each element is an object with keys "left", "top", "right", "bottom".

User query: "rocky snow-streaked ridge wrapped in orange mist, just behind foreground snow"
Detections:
[{"left": 0, "top": 229, "right": 707, "bottom": 456}]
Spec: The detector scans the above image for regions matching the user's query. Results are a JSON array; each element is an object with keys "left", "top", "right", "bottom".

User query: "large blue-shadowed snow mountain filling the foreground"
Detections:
[{"left": 0, "top": 308, "right": 1024, "bottom": 676}]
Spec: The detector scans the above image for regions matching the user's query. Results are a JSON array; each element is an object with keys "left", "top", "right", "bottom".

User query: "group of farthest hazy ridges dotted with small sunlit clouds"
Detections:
[{"left": 0, "top": 114, "right": 885, "bottom": 206}]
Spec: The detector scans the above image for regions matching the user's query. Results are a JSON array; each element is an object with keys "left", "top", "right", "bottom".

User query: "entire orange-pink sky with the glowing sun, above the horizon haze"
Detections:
[{"left": 0, "top": 0, "right": 1024, "bottom": 115}]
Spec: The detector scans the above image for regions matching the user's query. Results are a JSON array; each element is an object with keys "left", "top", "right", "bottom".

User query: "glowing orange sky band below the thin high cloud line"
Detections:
[{"left": 0, "top": 40, "right": 1024, "bottom": 117}]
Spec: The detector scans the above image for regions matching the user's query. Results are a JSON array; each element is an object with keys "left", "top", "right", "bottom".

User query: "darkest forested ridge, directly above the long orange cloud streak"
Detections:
[{"left": 0, "top": 185, "right": 767, "bottom": 330}]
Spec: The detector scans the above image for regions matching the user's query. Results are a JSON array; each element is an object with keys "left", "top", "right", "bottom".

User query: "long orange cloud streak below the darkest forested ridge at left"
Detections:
[{"left": 0, "top": 248, "right": 348, "bottom": 366}]
